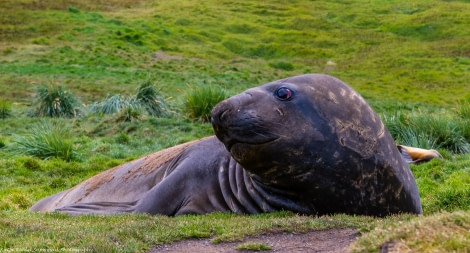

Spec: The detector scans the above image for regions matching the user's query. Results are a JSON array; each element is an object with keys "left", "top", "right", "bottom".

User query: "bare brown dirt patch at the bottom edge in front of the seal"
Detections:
[{"left": 147, "top": 228, "right": 358, "bottom": 253}]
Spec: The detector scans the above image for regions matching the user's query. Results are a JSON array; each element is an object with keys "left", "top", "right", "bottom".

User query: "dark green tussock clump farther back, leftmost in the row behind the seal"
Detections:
[{"left": 31, "top": 85, "right": 81, "bottom": 118}]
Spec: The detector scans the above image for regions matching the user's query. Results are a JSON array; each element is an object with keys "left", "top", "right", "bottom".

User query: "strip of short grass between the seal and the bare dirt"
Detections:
[{"left": 0, "top": 211, "right": 374, "bottom": 252}]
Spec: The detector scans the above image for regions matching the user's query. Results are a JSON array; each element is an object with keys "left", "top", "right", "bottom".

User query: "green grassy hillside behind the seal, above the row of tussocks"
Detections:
[{"left": 0, "top": 0, "right": 470, "bottom": 105}]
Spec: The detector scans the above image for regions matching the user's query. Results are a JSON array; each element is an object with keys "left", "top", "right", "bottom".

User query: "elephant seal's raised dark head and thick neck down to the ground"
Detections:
[{"left": 212, "top": 74, "right": 421, "bottom": 215}]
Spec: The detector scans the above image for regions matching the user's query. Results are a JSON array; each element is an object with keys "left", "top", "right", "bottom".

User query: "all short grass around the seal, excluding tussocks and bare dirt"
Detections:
[{"left": 0, "top": 0, "right": 470, "bottom": 252}]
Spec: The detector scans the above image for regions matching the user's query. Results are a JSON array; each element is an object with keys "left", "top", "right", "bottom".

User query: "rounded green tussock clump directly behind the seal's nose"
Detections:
[{"left": 183, "top": 86, "right": 228, "bottom": 122}]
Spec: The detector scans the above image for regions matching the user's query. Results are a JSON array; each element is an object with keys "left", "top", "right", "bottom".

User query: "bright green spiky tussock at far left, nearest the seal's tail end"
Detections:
[{"left": 9, "top": 121, "right": 78, "bottom": 161}]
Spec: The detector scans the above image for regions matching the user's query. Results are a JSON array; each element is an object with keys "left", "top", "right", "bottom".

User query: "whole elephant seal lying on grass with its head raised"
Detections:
[{"left": 31, "top": 74, "right": 422, "bottom": 216}]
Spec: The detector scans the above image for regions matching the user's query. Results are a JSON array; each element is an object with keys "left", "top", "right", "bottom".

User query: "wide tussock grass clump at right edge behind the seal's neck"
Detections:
[{"left": 384, "top": 112, "right": 470, "bottom": 153}]
